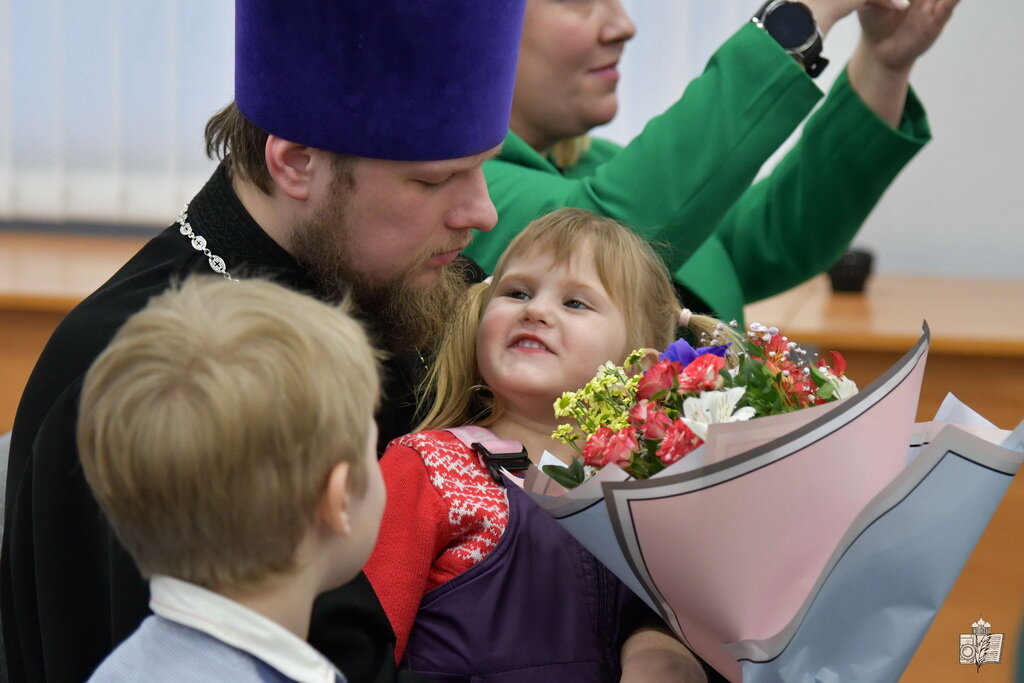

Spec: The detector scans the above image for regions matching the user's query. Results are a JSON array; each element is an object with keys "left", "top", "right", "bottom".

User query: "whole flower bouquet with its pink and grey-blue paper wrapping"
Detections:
[{"left": 524, "top": 326, "right": 1024, "bottom": 682}]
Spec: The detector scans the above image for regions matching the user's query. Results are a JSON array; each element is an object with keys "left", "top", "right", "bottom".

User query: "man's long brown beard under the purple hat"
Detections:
[{"left": 293, "top": 190, "right": 467, "bottom": 354}]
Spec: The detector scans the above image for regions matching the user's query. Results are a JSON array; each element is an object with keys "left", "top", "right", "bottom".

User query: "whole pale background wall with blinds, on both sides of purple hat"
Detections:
[{"left": 0, "top": 0, "right": 1024, "bottom": 278}]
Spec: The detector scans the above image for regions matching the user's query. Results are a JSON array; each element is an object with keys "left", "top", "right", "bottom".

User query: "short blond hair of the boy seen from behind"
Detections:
[{"left": 78, "top": 276, "right": 380, "bottom": 590}]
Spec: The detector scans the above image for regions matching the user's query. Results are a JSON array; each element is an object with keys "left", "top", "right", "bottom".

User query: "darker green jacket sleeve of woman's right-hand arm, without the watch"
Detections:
[{"left": 708, "top": 72, "right": 931, "bottom": 302}]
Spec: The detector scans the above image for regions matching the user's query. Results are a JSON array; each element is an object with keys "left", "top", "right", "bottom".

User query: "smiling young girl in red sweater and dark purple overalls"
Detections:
[{"left": 365, "top": 209, "right": 717, "bottom": 682}]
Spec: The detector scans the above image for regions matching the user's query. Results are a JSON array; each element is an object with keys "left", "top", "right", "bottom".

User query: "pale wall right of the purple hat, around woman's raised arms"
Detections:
[{"left": 598, "top": 0, "right": 1024, "bottom": 278}]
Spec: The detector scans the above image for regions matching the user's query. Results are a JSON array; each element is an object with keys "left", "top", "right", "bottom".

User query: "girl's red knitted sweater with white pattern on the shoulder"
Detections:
[{"left": 364, "top": 431, "right": 509, "bottom": 661}]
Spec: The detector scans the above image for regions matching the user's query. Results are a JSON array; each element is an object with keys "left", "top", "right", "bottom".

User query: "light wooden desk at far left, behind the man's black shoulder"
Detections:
[{"left": 0, "top": 232, "right": 146, "bottom": 433}]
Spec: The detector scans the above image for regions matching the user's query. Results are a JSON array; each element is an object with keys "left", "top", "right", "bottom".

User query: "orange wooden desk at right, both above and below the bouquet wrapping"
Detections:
[{"left": 746, "top": 275, "right": 1024, "bottom": 683}]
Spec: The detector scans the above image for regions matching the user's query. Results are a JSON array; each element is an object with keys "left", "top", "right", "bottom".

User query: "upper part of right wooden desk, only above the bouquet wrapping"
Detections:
[{"left": 746, "top": 275, "right": 1024, "bottom": 429}]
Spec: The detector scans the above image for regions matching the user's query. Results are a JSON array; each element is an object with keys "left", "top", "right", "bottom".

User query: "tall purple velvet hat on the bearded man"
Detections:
[{"left": 234, "top": 0, "right": 525, "bottom": 161}]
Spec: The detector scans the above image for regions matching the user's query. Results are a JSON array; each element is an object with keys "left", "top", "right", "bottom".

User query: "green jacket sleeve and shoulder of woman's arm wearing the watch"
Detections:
[{"left": 467, "top": 25, "right": 821, "bottom": 270}]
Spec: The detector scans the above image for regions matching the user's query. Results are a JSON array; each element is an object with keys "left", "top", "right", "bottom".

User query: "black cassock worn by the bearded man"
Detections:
[{"left": 0, "top": 166, "right": 468, "bottom": 683}]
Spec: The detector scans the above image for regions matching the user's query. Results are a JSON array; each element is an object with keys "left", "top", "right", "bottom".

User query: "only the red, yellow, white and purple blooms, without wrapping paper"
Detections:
[{"left": 544, "top": 323, "right": 857, "bottom": 488}]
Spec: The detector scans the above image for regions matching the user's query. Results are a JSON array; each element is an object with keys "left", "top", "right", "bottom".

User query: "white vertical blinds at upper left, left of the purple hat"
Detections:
[{"left": 0, "top": 0, "right": 234, "bottom": 225}]
